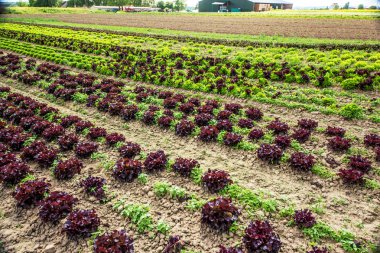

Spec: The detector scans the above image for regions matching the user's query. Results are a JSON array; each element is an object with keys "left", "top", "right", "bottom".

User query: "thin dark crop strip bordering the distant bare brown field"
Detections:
[{"left": 5, "top": 19, "right": 380, "bottom": 50}]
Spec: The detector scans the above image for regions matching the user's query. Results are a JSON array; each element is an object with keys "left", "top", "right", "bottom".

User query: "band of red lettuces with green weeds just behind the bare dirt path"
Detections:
[{"left": 2, "top": 52, "right": 378, "bottom": 188}]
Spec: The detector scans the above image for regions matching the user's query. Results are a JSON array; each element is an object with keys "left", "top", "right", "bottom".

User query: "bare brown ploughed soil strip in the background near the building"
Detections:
[{"left": 6, "top": 14, "right": 380, "bottom": 40}]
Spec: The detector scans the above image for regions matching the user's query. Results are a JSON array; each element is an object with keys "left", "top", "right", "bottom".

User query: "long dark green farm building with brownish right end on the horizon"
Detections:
[{"left": 199, "top": 0, "right": 293, "bottom": 12}]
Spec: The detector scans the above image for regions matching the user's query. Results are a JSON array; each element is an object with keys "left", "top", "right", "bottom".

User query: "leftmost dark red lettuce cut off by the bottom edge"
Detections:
[{"left": 94, "top": 230, "right": 135, "bottom": 253}]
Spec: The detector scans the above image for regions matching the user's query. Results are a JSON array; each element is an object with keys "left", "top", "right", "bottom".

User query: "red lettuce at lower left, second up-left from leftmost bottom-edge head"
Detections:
[{"left": 39, "top": 191, "right": 78, "bottom": 223}]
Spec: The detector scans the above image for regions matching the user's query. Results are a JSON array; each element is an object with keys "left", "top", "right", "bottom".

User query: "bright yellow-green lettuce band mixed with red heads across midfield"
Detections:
[{"left": 0, "top": 24, "right": 380, "bottom": 94}]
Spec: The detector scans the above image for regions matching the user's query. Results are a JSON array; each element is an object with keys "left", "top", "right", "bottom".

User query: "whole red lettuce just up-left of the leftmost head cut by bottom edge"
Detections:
[{"left": 63, "top": 210, "right": 100, "bottom": 237}]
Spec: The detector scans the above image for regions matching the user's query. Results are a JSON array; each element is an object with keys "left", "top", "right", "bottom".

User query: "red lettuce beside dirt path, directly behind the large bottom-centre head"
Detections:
[{"left": 202, "top": 170, "right": 232, "bottom": 193}]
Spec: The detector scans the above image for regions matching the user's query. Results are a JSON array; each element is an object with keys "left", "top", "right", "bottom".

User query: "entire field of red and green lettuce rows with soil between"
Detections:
[{"left": 0, "top": 12, "right": 380, "bottom": 253}]
